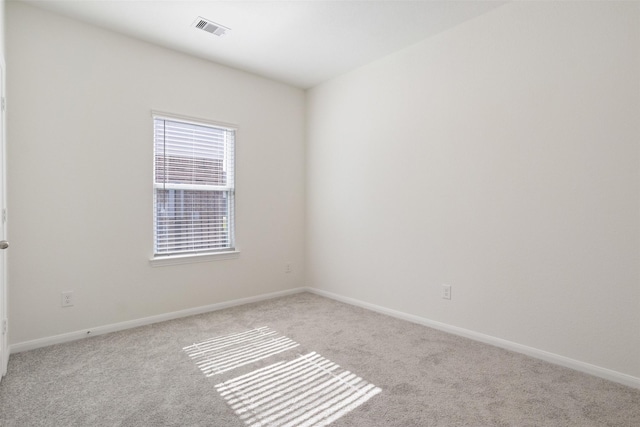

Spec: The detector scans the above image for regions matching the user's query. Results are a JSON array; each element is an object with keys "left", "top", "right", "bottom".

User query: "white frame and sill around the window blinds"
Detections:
[{"left": 149, "top": 111, "right": 240, "bottom": 267}]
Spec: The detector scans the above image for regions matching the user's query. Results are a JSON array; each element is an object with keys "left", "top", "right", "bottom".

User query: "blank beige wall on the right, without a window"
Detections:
[{"left": 307, "top": 2, "right": 640, "bottom": 377}]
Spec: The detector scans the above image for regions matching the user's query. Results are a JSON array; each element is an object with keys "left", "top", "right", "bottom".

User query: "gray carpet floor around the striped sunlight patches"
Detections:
[{"left": 0, "top": 293, "right": 640, "bottom": 427}]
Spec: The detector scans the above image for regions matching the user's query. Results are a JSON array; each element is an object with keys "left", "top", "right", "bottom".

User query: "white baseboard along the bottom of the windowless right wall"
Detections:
[{"left": 305, "top": 287, "right": 640, "bottom": 389}]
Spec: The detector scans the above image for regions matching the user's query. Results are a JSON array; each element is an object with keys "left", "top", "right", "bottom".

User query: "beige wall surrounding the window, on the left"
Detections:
[{"left": 7, "top": 3, "right": 305, "bottom": 344}]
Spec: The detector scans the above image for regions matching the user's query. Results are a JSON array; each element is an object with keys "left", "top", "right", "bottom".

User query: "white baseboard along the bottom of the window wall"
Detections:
[{"left": 9, "top": 288, "right": 307, "bottom": 354}]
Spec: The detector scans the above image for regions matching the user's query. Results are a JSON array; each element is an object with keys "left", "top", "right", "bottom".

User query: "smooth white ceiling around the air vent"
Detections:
[{"left": 22, "top": 0, "right": 505, "bottom": 88}]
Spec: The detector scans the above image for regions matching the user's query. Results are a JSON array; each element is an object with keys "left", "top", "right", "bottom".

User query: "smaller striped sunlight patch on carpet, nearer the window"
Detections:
[{"left": 183, "top": 326, "right": 299, "bottom": 377}]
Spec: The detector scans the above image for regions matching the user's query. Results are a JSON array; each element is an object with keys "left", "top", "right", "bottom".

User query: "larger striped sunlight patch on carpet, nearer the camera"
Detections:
[{"left": 216, "top": 352, "right": 381, "bottom": 427}]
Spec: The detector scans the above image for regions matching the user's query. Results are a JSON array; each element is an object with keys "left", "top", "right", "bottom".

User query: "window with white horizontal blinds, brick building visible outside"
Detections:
[{"left": 153, "top": 116, "right": 235, "bottom": 257}]
